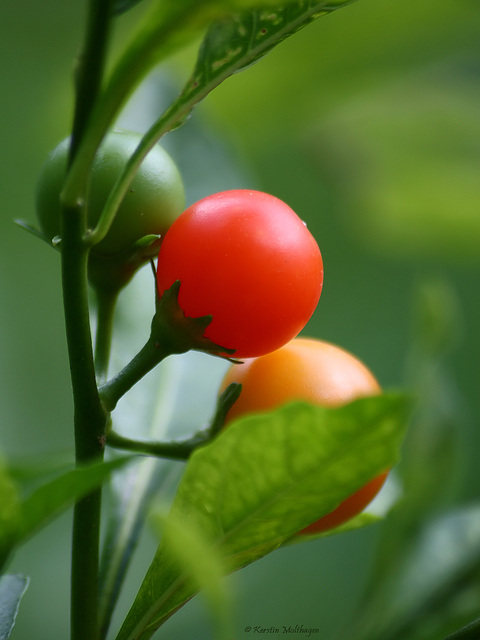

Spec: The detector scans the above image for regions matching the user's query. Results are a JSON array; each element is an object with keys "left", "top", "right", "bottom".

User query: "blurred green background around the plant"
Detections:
[{"left": 0, "top": 0, "right": 480, "bottom": 640}]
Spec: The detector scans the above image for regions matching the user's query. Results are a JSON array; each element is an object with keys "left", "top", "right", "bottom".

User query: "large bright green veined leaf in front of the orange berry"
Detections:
[{"left": 118, "top": 394, "right": 410, "bottom": 640}]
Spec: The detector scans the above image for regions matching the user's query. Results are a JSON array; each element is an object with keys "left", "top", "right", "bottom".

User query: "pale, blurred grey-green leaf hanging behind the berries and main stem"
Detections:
[{"left": 99, "top": 114, "right": 248, "bottom": 631}]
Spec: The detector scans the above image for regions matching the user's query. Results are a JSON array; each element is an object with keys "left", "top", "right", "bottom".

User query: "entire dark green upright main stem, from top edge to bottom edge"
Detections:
[{"left": 61, "top": 0, "right": 112, "bottom": 640}]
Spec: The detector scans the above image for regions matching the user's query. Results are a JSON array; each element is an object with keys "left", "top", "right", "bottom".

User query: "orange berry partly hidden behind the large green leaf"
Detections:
[{"left": 220, "top": 338, "right": 388, "bottom": 535}]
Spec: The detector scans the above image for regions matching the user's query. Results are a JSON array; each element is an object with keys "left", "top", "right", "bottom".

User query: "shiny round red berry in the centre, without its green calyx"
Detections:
[{"left": 157, "top": 189, "right": 323, "bottom": 358}]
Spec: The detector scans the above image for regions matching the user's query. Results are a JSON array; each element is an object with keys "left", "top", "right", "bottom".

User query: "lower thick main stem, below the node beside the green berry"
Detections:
[{"left": 62, "top": 209, "right": 107, "bottom": 640}]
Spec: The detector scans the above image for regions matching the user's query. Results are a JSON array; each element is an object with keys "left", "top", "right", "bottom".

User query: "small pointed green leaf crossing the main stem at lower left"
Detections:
[{"left": 16, "top": 457, "right": 132, "bottom": 542}]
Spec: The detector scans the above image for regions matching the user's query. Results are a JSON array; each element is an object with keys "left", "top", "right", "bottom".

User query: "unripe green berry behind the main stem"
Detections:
[{"left": 36, "top": 131, "right": 185, "bottom": 256}]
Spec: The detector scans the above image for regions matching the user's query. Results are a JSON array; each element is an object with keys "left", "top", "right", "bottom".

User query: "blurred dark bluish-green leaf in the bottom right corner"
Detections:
[{"left": 352, "top": 503, "right": 480, "bottom": 640}]
